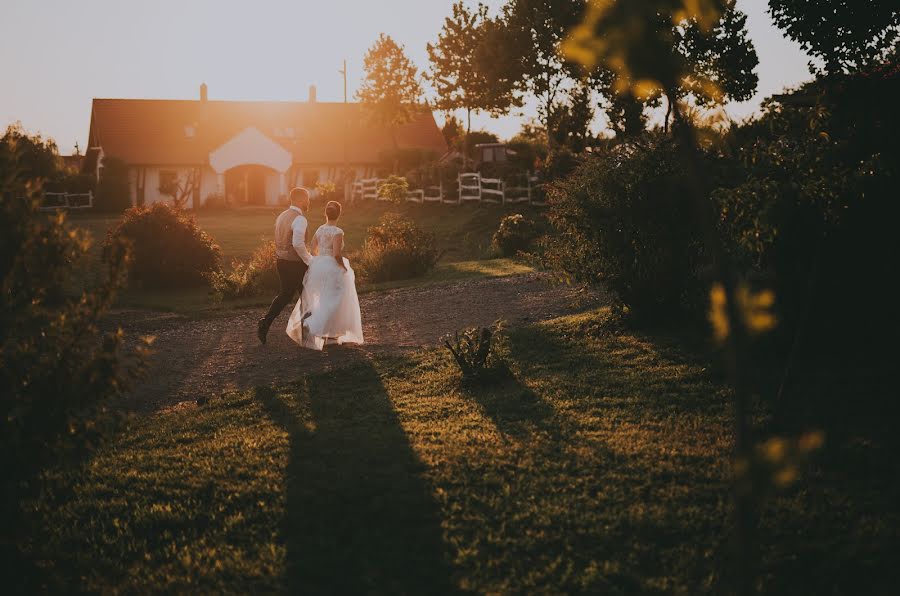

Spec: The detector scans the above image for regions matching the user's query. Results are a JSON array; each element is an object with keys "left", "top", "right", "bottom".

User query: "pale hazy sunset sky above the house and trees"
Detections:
[{"left": 0, "top": 0, "right": 809, "bottom": 153}]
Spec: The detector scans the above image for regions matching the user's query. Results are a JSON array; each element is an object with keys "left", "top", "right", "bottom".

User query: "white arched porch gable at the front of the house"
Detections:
[{"left": 209, "top": 127, "right": 293, "bottom": 203}]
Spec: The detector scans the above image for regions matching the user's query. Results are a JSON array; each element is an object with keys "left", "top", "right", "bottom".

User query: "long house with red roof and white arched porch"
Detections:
[{"left": 84, "top": 84, "right": 447, "bottom": 206}]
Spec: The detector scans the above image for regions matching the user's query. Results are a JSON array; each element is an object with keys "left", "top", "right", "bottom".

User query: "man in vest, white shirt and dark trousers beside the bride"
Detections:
[{"left": 256, "top": 187, "right": 312, "bottom": 343}]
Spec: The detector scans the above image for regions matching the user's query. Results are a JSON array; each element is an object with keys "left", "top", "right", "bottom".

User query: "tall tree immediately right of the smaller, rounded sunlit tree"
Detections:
[{"left": 426, "top": 2, "right": 513, "bottom": 134}]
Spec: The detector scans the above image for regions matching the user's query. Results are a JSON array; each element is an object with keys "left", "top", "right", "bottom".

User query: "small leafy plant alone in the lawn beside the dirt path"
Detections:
[{"left": 444, "top": 321, "right": 507, "bottom": 382}]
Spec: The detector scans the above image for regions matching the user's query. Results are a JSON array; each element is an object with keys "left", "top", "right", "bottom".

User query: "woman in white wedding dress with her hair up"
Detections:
[{"left": 287, "top": 201, "right": 363, "bottom": 350}]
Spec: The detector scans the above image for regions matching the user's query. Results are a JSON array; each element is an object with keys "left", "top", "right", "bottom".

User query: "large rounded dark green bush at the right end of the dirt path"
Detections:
[{"left": 545, "top": 139, "right": 705, "bottom": 318}]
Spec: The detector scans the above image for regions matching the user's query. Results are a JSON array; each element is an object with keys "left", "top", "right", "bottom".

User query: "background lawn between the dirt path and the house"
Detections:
[{"left": 71, "top": 203, "right": 542, "bottom": 314}]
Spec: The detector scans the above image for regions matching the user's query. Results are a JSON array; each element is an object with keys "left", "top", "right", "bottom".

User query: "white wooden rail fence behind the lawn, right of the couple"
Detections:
[{"left": 353, "top": 172, "right": 546, "bottom": 206}]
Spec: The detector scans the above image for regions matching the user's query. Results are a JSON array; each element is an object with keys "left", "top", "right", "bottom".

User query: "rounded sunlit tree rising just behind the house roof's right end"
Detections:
[{"left": 356, "top": 33, "right": 422, "bottom": 126}]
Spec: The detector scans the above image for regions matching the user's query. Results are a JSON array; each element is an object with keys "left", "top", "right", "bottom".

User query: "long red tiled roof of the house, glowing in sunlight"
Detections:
[{"left": 89, "top": 99, "right": 447, "bottom": 165}]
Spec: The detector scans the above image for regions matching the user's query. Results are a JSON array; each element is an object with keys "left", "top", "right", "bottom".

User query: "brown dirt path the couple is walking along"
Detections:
[{"left": 110, "top": 274, "right": 604, "bottom": 411}]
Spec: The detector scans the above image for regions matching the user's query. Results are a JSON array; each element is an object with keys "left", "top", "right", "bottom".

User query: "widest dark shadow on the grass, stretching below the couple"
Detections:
[{"left": 256, "top": 363, "right": 456, "bottom": 594}]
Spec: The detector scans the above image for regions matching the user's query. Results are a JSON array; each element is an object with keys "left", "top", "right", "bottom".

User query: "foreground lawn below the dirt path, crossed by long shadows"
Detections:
[{"left": 21, "top": 310, "right": 900, "bottom": 594}]
